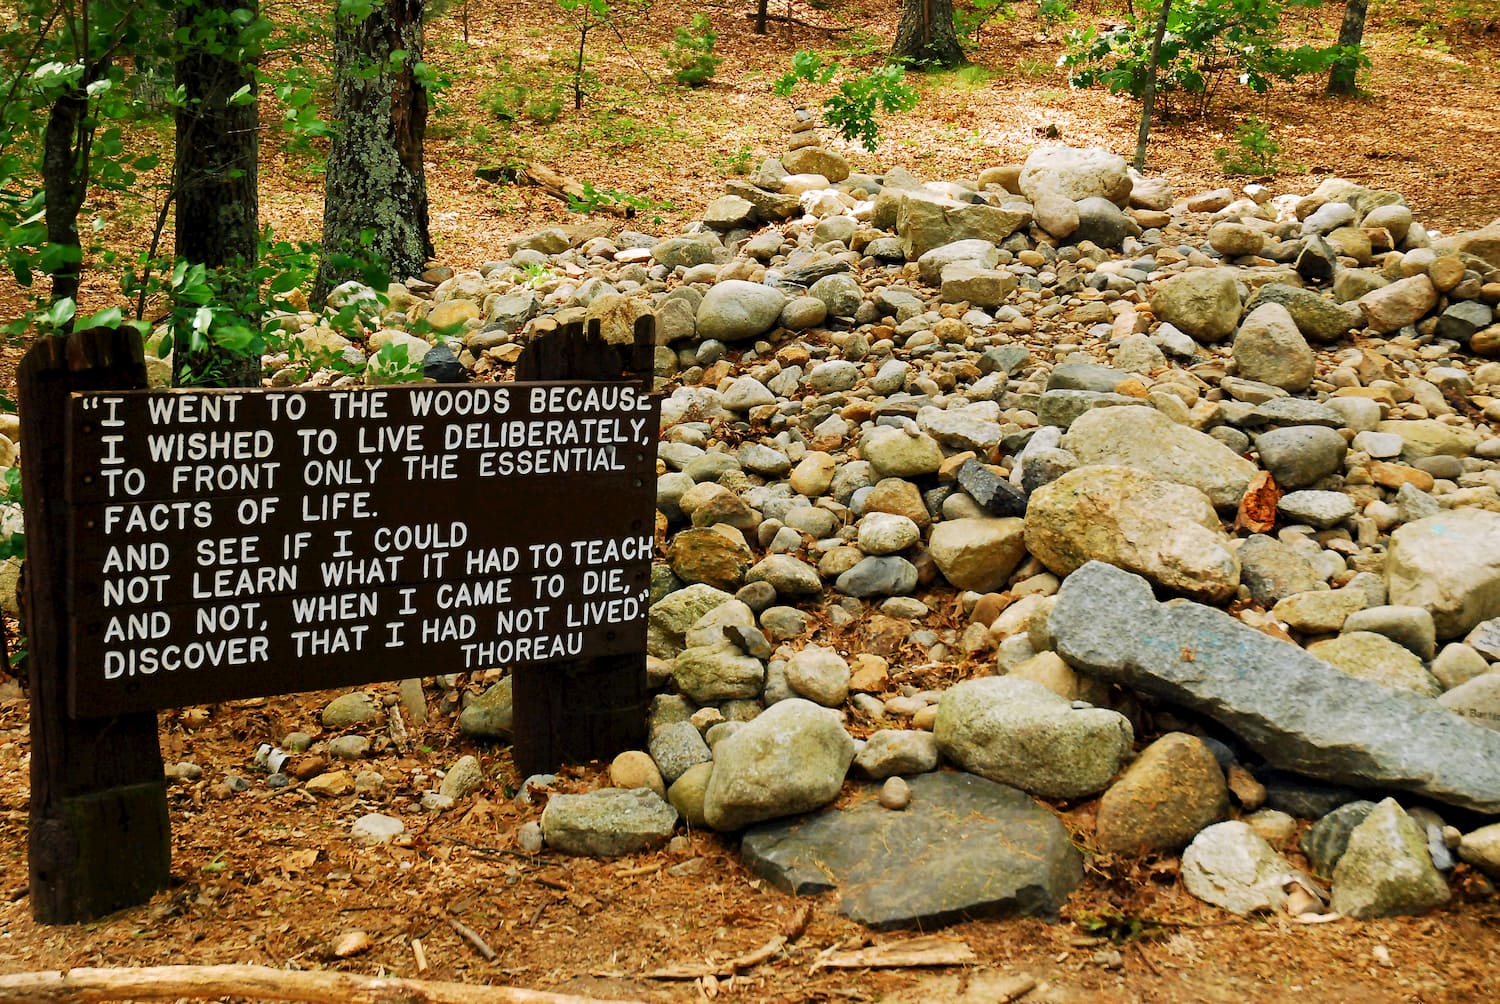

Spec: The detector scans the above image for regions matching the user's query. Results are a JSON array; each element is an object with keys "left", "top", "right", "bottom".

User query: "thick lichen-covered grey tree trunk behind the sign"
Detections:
[{"left": 318, "top": 0, "right": 432, "bottom": 299}]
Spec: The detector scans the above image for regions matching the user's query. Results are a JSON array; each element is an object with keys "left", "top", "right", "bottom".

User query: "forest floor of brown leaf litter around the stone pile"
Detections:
[{"left": 0, "top": 0, "right": 1500, "bottom": 1002}]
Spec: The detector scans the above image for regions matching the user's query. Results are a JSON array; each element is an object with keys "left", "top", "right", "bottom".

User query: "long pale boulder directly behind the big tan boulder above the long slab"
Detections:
[{"left": 1062, "top": 405, "right": 1259, "bottom": 509}]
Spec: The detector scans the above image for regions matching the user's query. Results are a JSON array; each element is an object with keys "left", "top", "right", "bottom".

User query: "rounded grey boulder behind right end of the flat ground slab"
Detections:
[{"left": 933, "top": 677, "right": 1134, "bottom": 798}]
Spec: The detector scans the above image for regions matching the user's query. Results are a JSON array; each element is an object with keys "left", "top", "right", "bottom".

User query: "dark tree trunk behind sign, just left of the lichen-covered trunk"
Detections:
[{"left": 173, "top": 0, "right": 261, "bottom": 387}]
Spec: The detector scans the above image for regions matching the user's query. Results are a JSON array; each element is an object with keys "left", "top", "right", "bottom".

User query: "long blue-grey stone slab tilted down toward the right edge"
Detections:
[{"left": 1047, "top": 561, "right": 1500, "bottom": 815}]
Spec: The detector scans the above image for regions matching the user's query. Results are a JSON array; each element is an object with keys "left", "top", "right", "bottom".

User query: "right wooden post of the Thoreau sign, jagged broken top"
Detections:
[{"left": 512, "top": 315, "right": 656, "bottom": 777}]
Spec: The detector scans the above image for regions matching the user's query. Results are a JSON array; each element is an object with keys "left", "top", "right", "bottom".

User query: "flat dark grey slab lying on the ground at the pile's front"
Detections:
[{"left": 741, "top": 773, "right": 1083, "bottom": 930}]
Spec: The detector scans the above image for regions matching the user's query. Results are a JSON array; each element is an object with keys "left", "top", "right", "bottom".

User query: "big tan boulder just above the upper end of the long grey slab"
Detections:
[{"left": 1020, "top": 465, "right": 1239, "bottom": 603}]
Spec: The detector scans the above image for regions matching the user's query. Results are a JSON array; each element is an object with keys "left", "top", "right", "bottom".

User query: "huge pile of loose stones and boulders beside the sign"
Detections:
[{"left": 11, "top": 138, "right": 1500, "bottom": 926}]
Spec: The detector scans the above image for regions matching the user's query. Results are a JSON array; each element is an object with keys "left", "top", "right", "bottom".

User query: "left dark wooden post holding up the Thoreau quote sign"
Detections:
[{"left": 17, "top": 329, "right": 171, "bottom": 924}]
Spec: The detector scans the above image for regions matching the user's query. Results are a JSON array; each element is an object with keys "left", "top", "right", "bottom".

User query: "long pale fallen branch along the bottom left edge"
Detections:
[{"left": 0, "top": 965, "right": 639, "bottom": 1004}]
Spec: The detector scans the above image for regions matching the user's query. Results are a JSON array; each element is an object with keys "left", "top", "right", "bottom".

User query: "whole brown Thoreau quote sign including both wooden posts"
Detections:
[{"left": 20, "top": 321, "right": 659, "bottom": 923}]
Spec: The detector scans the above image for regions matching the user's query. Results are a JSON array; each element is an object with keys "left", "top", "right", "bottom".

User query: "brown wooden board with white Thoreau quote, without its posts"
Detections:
[{"left": 65, "top": 383, "right": 660, "bottom": 717}]
